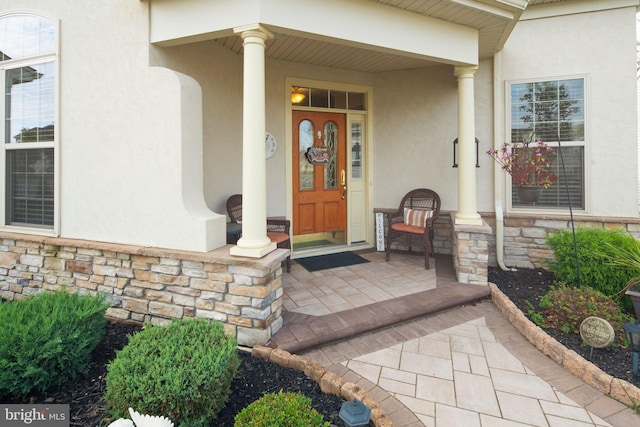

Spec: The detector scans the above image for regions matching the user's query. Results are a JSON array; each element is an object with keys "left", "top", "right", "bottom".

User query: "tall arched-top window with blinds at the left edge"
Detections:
[{"left": 0, "top": 14, "right": 57, "bottom": 228}]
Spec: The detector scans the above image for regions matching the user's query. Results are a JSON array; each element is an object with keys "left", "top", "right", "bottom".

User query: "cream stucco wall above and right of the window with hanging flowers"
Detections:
[{"left": 501, "top": 8, "right": 638, "bottom": 217}]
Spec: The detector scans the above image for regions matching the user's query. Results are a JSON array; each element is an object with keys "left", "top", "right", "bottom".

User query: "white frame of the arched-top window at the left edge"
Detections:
[{"left": 0, "top": 11, "right": 60, "bottom": 236}]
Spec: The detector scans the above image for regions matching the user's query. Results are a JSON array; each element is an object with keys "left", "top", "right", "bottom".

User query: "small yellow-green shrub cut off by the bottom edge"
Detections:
[{"left": 233, "top": 390, "right": 330, "bottom": 427}]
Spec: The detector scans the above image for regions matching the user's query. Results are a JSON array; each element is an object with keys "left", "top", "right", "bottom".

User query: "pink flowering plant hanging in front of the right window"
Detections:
[{"left": 487, "top": 141, "right": 558, "bottom": 188}]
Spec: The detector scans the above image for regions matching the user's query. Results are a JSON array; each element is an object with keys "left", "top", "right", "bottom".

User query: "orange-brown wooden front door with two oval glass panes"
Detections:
[{"left": 292, "top": 111, "right": 347, "bottom": 236}]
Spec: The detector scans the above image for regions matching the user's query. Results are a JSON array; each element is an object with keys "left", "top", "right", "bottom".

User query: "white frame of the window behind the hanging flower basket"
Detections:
[{"left": 504, "top": 74, "right": 590, "bottom": 215}]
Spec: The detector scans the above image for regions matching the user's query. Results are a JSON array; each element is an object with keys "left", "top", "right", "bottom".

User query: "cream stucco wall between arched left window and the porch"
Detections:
[{"left": 0, "top": 0, "right": 226, "bottom": 251}]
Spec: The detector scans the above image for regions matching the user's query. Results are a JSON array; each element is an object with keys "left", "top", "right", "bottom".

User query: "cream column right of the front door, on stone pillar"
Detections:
[{"left": 454, "top": 67, "right": 482, "bottom": 225}]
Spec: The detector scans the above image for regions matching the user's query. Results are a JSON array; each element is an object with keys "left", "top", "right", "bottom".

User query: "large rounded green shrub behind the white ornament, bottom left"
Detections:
[{"left": 105, "top": 319, "right": 240, "bottom": 427}]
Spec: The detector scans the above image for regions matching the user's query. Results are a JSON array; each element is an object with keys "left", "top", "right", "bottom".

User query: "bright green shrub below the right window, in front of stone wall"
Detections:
[{"left": 547, "top": 228, "right": 640, "bottom": 307}]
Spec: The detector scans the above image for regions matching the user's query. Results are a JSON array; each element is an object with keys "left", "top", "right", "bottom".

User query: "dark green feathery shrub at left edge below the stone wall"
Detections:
[{"left": 0, "top": 292, "right": 108, "bottom": 395}]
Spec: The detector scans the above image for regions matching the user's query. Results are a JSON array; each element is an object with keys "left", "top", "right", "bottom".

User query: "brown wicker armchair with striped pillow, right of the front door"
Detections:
[{"left": 385, "top": 188, "right": 440, "bottom": 269}]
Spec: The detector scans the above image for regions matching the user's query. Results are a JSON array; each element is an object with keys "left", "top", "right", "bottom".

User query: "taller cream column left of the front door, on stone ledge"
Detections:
[{"left": 229, "top": 24, "right": 276, "bottom": 258}]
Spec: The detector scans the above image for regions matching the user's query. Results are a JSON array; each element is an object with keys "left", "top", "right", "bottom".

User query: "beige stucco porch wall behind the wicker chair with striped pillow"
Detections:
[{"left": 373, "top": 60, "right": 493, "bottom": 211}]
